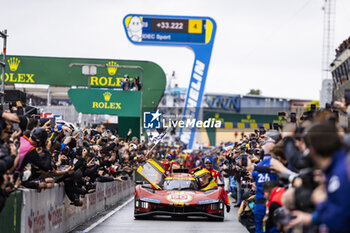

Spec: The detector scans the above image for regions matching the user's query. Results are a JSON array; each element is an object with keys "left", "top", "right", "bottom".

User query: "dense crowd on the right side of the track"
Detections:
[{"left": 202, "top": 106, "right": 350, "bottom": 232}]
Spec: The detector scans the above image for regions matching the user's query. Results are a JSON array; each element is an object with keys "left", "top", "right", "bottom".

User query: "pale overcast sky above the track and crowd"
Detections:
[{"left": 0, "top": 0, "right": 350, "bottom": 99}]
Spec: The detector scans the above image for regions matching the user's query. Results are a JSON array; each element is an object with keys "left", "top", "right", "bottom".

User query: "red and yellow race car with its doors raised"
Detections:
[{"left": 134, "top": 159, "right": 225, "bottom": 221}]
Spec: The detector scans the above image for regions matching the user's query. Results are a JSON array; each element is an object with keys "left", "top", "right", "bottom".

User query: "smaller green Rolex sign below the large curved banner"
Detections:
[{"left": 68, "top": 89, "right": 141, "bottom": 117}]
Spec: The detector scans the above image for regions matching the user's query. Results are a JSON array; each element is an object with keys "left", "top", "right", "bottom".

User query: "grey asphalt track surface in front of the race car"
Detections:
[{"left": 89, "top": 198, "right": 248, "bottom": 233}]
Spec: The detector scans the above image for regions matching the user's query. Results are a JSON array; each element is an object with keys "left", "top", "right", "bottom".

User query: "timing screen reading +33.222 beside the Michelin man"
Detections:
[{"left": 124, "top": 15, "right": 211, "bottom": 44}]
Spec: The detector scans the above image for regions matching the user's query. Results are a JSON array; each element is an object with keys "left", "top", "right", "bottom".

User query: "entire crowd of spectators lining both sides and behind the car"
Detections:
[{"left": 0, "top": 97, "right": 350, "bottom": 232}]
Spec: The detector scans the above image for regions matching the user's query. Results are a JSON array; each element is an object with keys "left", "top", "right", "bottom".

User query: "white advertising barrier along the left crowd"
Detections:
[{"left": 1, "top": 180, "right": 134, "bottom": 233}]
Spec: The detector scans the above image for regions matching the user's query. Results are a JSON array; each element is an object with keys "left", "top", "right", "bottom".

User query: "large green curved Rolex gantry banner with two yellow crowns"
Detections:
[{"left": 0, "top": 55, "right": 166, "bottom": 111}]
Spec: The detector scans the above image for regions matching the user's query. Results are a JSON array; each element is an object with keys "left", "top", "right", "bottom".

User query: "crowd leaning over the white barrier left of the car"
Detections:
[{"left": 0, "top": 103, "right": 149, "bottom": 212}]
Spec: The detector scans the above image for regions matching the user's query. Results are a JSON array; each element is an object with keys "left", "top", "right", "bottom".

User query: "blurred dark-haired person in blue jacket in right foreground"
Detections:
[{"left": 290, "top": 123, "right": 350, "bottom": 233}]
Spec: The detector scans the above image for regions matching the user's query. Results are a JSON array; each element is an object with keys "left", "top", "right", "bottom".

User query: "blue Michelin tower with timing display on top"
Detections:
[{"left": 123, "top": 14, "right": 216, "bottom": 149}]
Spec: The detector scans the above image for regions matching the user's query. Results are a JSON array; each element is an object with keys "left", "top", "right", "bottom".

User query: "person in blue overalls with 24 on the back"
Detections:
[{"left": 252, "top": 142, "right": 277, "bottom": 233}]
